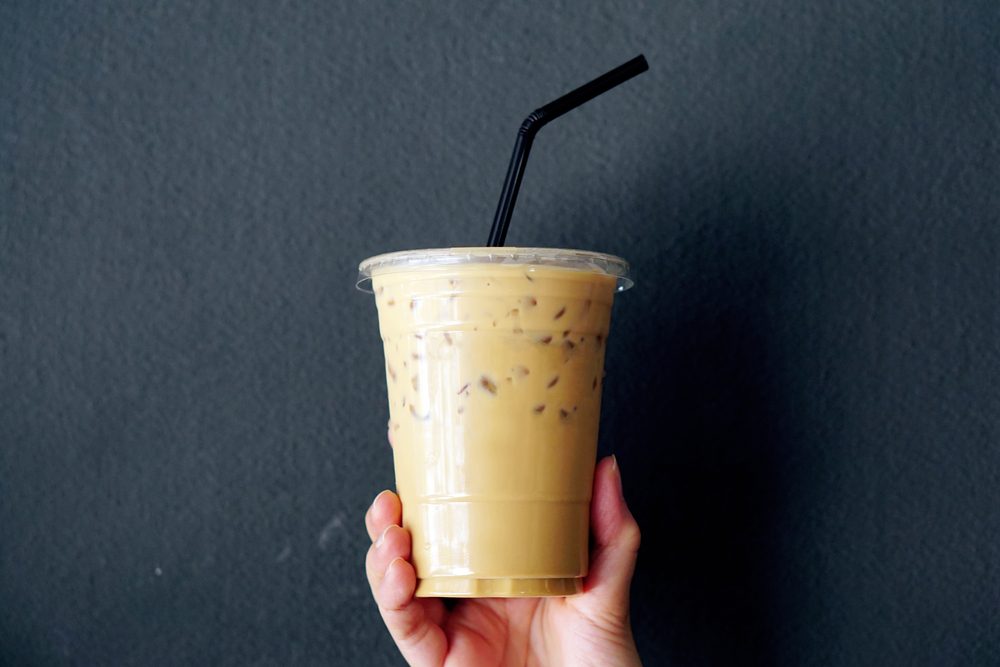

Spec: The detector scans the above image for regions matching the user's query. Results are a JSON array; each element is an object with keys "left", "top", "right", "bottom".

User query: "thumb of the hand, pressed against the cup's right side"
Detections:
[{"left": 584, "top": 456, "right": 639, "bottom": 622}]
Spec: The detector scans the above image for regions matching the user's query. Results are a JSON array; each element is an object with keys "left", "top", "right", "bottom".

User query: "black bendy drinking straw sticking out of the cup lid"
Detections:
[{"left": 486, "top": 55, "right": 649, "bottom": 247}]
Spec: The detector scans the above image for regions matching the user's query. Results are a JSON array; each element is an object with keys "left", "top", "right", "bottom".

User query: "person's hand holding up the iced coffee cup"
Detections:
[{"left": 365, "top": 457, "right": 641, "bottom": 667}]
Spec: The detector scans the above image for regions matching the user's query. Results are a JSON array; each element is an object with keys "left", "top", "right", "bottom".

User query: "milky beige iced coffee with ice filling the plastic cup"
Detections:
[{"left": 372, "top": 263, "right": 616, "bottom": 597}]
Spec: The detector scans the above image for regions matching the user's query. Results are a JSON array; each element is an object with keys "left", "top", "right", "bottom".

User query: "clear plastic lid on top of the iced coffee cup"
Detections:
[{"left": 357, "top": 247, "right": 634, "bottom": 292}]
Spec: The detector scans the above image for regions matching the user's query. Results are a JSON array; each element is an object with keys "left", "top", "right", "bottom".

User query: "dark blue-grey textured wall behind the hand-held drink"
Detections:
[{"left": 0, "top": 0, "right": 1000, "bottom": 665}]
